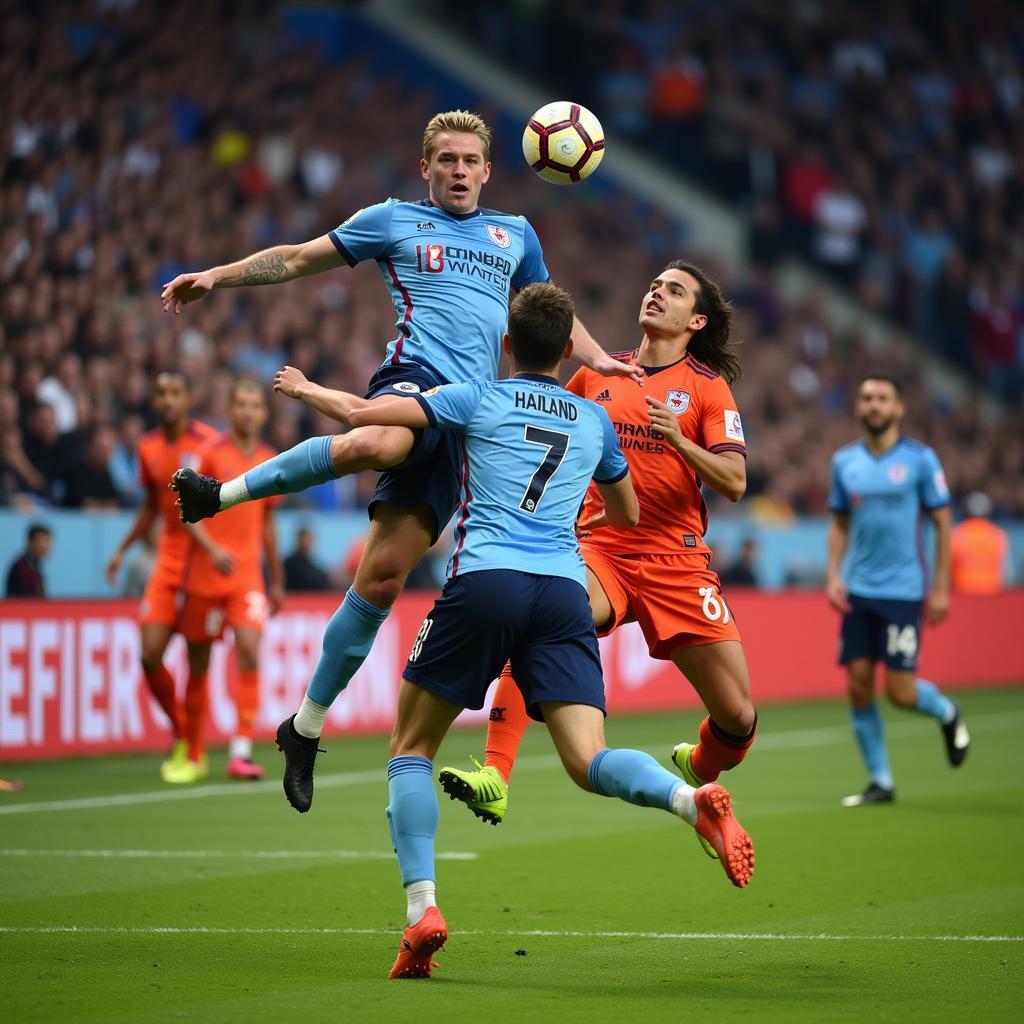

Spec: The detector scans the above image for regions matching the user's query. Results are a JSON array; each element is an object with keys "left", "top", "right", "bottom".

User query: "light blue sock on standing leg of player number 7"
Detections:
[{"left": 387, "top": 757, "right": 437, "bottom": 886}]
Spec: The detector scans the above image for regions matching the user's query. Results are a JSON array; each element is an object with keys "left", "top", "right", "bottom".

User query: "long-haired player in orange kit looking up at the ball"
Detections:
[{"left": 440, "top": 260, "right": 757, "bottom": 855}]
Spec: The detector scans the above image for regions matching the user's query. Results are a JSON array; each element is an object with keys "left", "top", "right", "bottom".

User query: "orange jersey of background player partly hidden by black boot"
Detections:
[{"left": 185, "top": 434, "right": 284, "bottom": 597}]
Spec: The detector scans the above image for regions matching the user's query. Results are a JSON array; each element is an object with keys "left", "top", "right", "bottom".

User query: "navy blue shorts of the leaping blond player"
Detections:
[{"left": 365, "top": 362, "right": 463, "bottom": 543}]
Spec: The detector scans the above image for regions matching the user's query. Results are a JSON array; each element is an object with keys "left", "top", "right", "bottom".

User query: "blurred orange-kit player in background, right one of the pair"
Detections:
[{"left": 168, "top": 380, "right": 284, "bottom": 782}]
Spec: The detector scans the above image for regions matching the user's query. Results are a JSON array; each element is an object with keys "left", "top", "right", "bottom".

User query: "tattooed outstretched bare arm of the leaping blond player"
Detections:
[{"left": 160, "top": 234, "right": 348, "bottom": 313}]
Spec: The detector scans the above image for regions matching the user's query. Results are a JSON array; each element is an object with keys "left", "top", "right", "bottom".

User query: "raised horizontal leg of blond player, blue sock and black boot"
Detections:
[{"left": 171, "top": 427, "right": 416, "bottom": 522}]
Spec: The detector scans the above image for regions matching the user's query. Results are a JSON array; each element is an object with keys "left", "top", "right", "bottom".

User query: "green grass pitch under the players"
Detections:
[{"left": 0, "top": 689, "right": 1024, "bottom": 1024}]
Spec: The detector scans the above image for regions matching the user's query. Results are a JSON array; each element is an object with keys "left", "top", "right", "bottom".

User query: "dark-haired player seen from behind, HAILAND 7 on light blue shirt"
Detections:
[{"left": 274, "top": 285, "right": 754, "bottom": 978}]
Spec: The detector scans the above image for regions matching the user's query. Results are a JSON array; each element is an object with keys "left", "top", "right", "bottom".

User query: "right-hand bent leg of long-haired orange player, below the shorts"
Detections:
[{"left": 672, "top": 640, "right": 758, "bottom": 785}]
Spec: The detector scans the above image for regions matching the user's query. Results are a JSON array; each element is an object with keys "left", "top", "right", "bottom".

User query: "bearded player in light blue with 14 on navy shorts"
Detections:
[{"left": 826, "top": 376, "right": 970, "bottom": 807}]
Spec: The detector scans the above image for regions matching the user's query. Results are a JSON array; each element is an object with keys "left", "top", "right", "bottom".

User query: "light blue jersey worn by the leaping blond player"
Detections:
[{"left": 329, "top": 199, "right": 550, "bottom": 382}]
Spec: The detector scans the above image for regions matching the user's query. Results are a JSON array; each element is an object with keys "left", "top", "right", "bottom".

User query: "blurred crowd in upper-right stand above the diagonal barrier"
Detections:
[{"left": 452, "top": 0, "right": 1024, "bottom": 401}]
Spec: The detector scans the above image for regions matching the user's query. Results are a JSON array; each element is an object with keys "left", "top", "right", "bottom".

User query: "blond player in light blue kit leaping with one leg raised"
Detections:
[{"left": 162, "top": 111, "right": 639, "bottom": 811}]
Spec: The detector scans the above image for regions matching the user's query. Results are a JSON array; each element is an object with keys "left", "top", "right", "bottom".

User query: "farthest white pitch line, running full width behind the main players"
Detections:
[{"left": 0, "top": 712, "right": 1024, "bottom": 815}]
